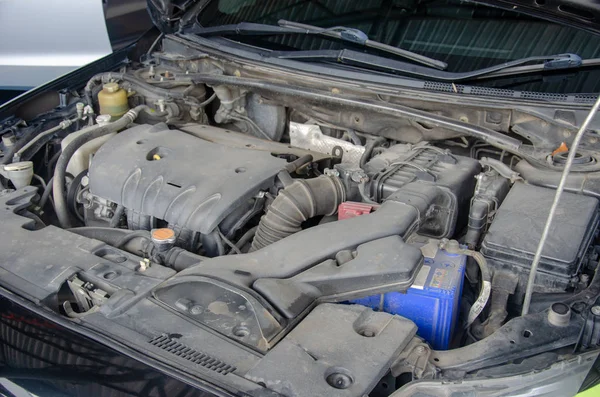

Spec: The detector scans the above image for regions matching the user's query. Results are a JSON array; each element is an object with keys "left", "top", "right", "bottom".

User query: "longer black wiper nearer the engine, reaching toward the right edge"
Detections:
[{"left": 265, "top": 50, "right": 583, "bottom": 82}]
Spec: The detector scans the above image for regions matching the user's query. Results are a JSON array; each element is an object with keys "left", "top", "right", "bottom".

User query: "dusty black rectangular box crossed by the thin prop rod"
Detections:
[{"left": 481, "top": 183, "right": 598, "bottom": 300}]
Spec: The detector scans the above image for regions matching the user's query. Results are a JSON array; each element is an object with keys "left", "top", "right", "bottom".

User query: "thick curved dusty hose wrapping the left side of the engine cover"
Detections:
[{"left": 52, "top": 105, "right": 148, "bottom": 229}]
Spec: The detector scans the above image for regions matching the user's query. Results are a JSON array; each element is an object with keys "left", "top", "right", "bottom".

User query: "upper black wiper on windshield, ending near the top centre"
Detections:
[{"left": 182, "top": 19, "right": 448, "bottom": 70}]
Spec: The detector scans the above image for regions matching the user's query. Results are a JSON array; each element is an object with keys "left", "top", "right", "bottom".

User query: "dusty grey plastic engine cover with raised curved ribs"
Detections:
[{"left": 89, "top": 124, "right": 286, "bottom": 234}]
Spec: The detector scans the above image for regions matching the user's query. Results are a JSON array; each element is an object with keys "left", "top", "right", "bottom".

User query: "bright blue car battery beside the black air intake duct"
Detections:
[{"left": 350, "top": 249, "right": 467, "bottom": 350}]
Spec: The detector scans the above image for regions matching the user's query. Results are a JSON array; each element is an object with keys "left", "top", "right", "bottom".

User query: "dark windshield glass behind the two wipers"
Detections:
[{"left": 198, "top": 0, "right": 600, "bottom": 93}]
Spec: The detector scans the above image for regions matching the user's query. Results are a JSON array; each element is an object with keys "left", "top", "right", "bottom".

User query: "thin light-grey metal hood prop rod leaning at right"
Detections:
[{"left": 521, "top": 95, "right": 600, "bottom": 316}]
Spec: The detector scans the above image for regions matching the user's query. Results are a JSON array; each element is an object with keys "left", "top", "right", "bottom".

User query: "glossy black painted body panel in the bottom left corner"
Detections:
[{"left": 0, "top": 298, "right": 214, "bottom": 397}]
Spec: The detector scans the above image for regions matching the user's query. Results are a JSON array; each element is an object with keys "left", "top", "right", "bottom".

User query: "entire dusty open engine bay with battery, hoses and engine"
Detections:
[{"left": 0, "top": 37, "right": 600, "bottom": 397}]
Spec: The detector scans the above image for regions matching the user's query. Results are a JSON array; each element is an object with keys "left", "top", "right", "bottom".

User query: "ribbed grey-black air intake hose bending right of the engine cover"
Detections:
[{"left": 250, "top": 176, "right": 346, "bottom": 251}]
